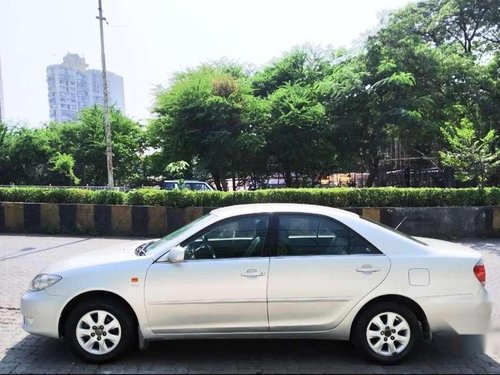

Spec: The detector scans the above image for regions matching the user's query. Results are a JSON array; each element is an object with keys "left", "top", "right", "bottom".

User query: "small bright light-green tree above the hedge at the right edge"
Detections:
[{"left": 439, "top": 118, "right": 500, "bottom": 187}]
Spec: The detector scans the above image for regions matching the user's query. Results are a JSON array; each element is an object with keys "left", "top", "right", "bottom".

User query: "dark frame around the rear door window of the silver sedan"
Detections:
[{"left": 270, "top": 211, "right": 386, "bottom": 258}]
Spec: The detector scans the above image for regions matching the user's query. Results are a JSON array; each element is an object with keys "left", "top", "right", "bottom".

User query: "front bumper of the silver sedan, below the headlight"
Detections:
[{"left": 21, "top": 290, "right": 64, "bottom": 338}]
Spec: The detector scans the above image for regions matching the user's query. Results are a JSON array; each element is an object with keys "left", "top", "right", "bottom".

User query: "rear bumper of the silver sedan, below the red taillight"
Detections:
[{"left": 417, "top": 288, "right": 493, "bottom": 335}]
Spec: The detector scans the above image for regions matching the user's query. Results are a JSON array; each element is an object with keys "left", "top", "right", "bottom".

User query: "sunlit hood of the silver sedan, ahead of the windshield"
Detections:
[{"left": 41, "top": 239, "right": 148, "bottom": 274}]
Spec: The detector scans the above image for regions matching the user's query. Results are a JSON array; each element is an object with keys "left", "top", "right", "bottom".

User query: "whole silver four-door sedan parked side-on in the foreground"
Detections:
[{"left": 21, "top": 204, "right": 492, "bottom": 364}]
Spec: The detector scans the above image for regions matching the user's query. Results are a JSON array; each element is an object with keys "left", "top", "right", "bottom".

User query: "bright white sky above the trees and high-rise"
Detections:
[{"left": 0, "top": 0, "right": 410, "bottom": 126}]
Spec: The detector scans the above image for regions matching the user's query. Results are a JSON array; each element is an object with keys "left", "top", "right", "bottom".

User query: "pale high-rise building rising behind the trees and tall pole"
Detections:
[{"left": 47, "top": 53, "right": 125, "bottom": 121}]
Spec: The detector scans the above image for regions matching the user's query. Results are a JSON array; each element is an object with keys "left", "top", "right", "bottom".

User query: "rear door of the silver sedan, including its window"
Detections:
[{"left": 268, "top": 214, "right": 390, "bottom": 331}]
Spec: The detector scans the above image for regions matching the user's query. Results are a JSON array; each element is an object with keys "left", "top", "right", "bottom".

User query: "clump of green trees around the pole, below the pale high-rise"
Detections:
[{"left": 0, "top": 107, "right": 144, "bottom": 185}]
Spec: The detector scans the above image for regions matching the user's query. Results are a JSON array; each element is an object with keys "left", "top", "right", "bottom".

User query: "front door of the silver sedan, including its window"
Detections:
[{"left": 145, "top": 215, "right": 269, "bottom": 334}]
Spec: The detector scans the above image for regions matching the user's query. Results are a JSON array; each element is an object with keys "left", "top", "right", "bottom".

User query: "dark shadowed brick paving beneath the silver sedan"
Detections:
[{"left": 0, "top": 335, "right": 500, "bottom": 374}]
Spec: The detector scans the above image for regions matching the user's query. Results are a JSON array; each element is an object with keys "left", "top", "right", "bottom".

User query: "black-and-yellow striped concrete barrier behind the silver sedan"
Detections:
[{"left": 0, "top": 202, "right": 500, "bottom": 238}]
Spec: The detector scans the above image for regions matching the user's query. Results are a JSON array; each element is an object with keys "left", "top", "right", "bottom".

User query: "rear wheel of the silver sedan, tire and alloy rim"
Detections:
[{"left": 352, "top": 302, "right": 421, "bottom": 365}]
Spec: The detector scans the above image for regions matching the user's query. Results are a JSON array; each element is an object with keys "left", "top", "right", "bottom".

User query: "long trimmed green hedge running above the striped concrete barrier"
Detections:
[{"left": 0, "top": 187, "right": 500, "bottom": 207}]
